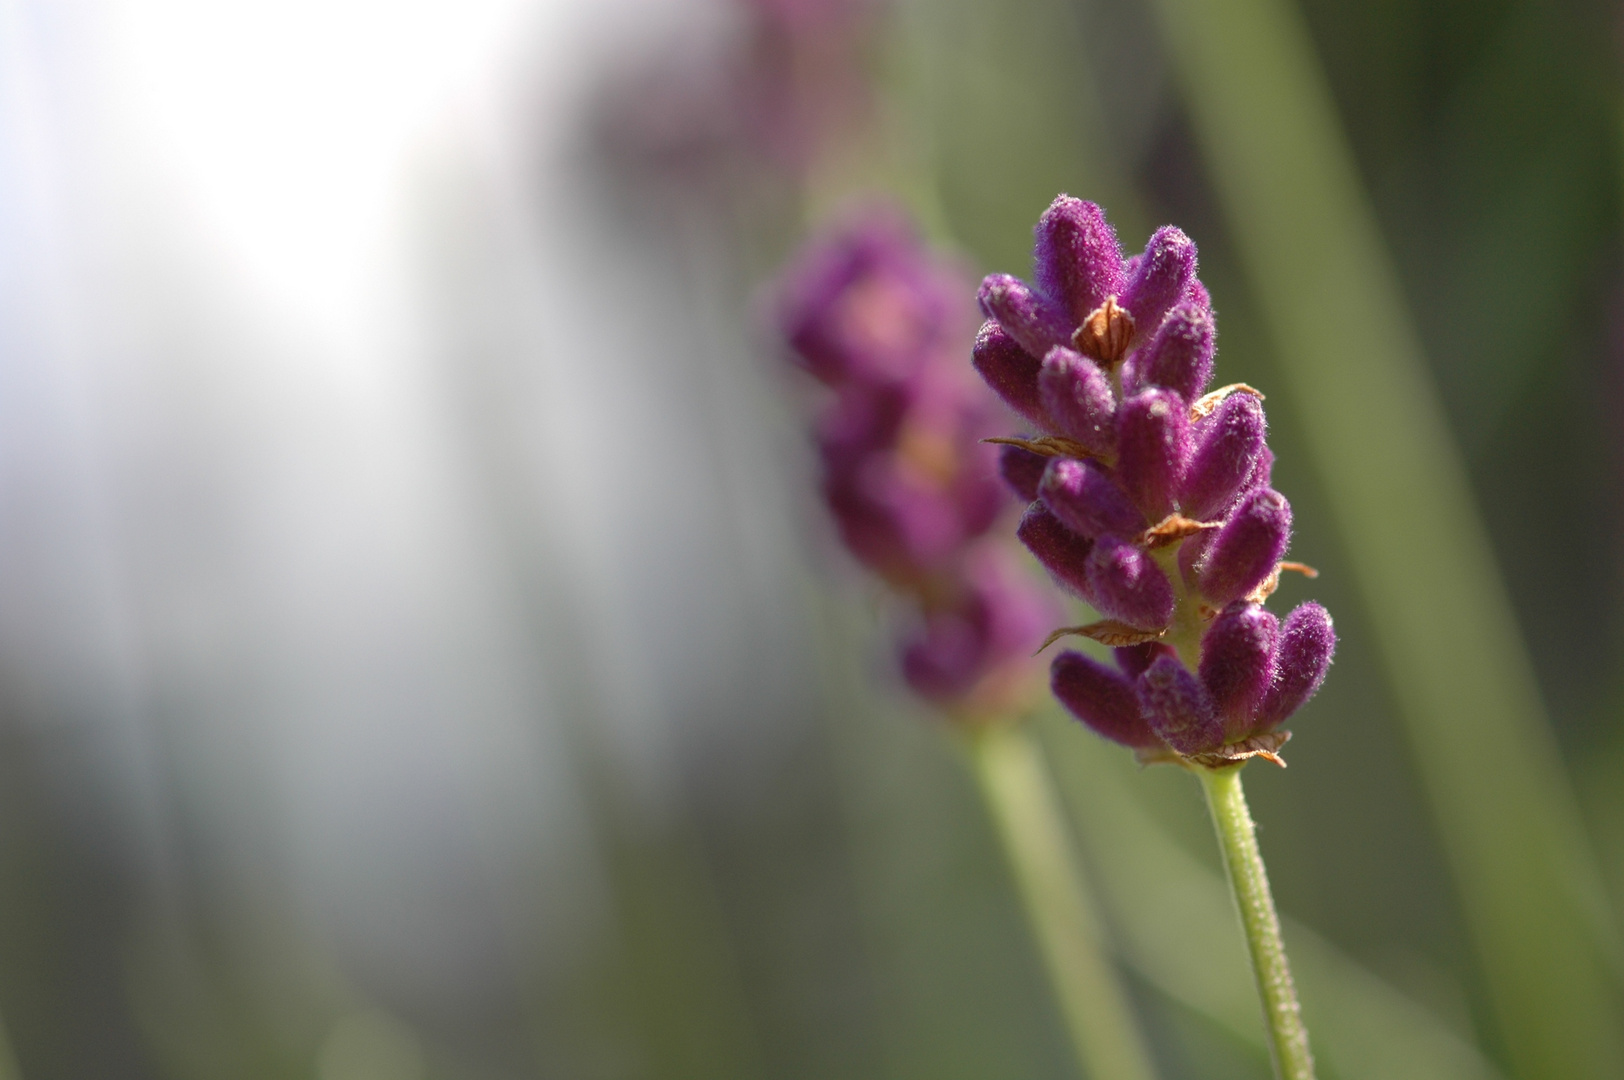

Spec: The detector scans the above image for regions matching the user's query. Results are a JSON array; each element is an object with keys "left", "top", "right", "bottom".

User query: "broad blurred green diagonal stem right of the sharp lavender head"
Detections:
[{"left": 1153, "top": 0, "right": 1624, "bottom": 1080}]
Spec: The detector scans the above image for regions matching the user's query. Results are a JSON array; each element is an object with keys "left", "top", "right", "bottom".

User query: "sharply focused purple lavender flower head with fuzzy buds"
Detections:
[{"left": 974, "top": 195, "right": 1337, "bottom": 765}]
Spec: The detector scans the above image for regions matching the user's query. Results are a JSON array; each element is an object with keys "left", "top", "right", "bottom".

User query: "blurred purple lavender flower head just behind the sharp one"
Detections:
[{"left": 776, "top": 211, "right": 1056, "bottom": 713}]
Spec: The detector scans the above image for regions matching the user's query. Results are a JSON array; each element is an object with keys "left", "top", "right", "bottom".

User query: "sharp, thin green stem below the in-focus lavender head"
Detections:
[{"left": 1194, "top": 765, "right": 1314, "bottom": 1080}]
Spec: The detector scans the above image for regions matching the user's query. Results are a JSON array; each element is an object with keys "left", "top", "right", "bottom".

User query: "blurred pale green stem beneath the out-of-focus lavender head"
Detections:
[{"left": 970, "top": 724, "right": 1156, "bottom": 1080}]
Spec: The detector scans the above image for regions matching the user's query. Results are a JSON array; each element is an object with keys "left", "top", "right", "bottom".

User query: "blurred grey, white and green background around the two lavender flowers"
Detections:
[{"left": 0, "top": 0, "right": 1624, "bottom": 1080}]
